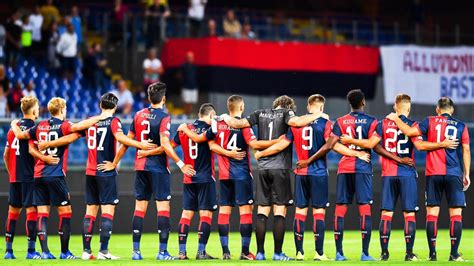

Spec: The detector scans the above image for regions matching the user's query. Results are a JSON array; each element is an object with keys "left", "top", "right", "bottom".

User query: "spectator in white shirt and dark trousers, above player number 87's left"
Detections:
[{"left": 56, "top": 23, "right": 77, "bottom": 80}]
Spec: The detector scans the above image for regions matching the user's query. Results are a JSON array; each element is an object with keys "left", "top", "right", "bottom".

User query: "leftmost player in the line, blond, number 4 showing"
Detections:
[{"left": 3, "top": 97, "right": 47, "bottom": 259}]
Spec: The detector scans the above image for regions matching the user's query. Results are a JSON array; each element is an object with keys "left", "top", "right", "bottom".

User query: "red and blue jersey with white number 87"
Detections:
[{"left": 84, "top": 116, "right": 122, "bottom": 176}]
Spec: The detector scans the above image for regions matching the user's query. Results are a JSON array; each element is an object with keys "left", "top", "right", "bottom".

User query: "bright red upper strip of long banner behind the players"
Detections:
[{"left": 161, "top": 38, "right": 379, "bottom": 74}]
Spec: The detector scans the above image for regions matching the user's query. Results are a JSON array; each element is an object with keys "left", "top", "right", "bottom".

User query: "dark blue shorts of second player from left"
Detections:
[{"left": 33, "top": 176, "right": 71, "bottom": 206}]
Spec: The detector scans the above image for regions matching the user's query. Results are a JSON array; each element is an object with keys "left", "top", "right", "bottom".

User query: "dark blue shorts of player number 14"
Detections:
[{"left": 219, "top": 179, "right": 253, "bottom": 207}]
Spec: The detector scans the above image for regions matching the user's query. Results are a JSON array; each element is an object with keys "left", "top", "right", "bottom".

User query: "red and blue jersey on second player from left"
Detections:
[{"left": 28, "top": 117, "right": 71, "bottom": 178}]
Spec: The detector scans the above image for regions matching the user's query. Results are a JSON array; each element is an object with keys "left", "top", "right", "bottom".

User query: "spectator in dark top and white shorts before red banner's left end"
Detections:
[{"left": 180, "top": 51, "right": 199, "bottom": 116}]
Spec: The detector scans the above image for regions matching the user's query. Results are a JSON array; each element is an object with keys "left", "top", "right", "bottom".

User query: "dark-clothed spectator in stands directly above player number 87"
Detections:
[{"left": 82, "top": 43, "right": 107, "bottom": 90}]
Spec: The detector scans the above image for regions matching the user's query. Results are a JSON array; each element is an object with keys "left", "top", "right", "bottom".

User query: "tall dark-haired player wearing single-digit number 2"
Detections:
[{"left": 113, "top": 82, "right": 194, "bottom": 260}]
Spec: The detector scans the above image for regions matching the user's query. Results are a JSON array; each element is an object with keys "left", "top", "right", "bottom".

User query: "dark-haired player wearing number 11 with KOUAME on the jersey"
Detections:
[{"left": 326, "top": 90, "right": 412, "bottom": 261}]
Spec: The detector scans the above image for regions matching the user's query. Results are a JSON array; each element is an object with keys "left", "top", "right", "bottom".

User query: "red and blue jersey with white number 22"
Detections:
[{"left": 377, "top": 115, "right": 419, "bottom": 176}]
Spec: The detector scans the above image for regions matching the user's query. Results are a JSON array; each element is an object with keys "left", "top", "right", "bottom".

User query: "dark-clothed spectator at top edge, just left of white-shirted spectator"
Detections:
[{"left": 145, "top": 0, "right": 171, "bottom": 48}]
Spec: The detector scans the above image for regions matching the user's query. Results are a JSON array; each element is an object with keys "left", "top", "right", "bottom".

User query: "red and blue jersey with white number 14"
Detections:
[{"left": 211, "top": 121, "right": 256, "bottom": 180}]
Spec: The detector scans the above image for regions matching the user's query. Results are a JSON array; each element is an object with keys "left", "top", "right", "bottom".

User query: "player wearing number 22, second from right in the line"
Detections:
[{"left": 341, "top": 94, "right": 457, "bottom": 261}]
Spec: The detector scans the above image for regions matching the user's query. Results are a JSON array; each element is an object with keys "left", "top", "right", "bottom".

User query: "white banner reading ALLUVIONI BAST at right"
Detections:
[{"left": 380, "top": 45, "right": 474, "bottom": 104}]
